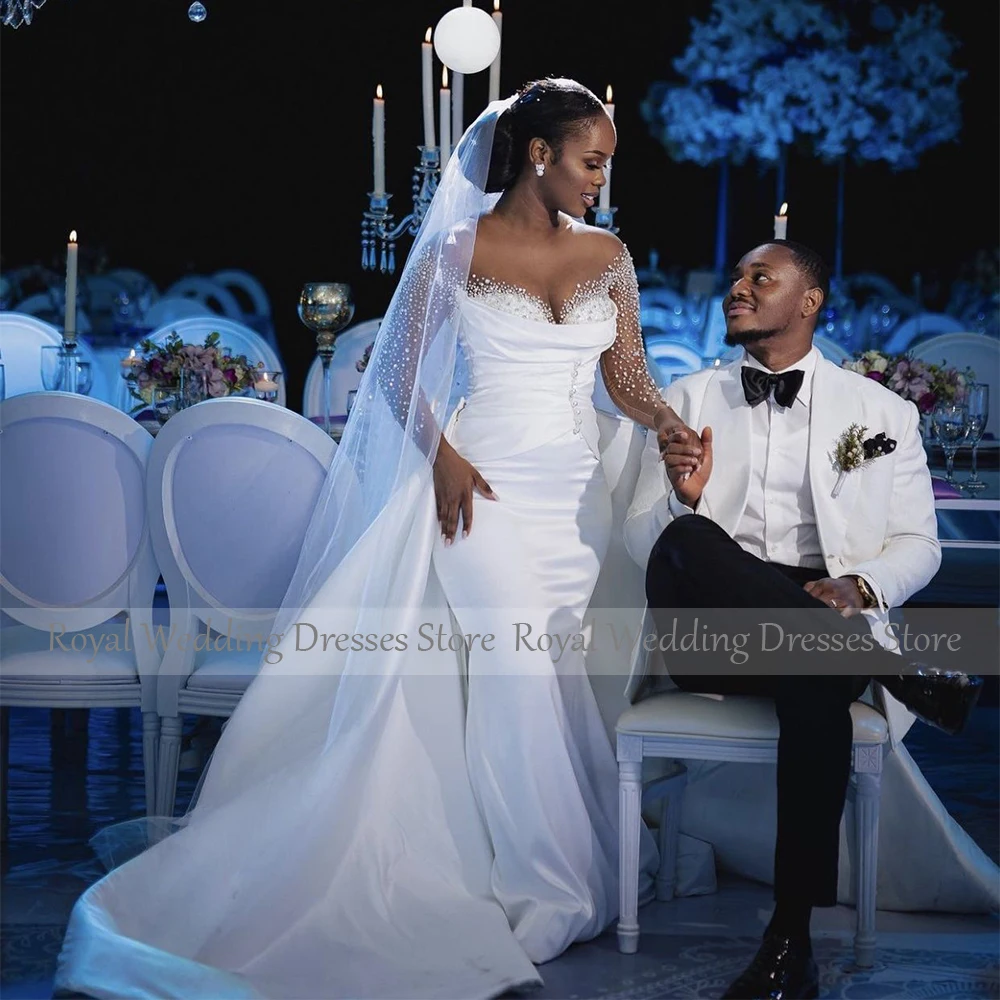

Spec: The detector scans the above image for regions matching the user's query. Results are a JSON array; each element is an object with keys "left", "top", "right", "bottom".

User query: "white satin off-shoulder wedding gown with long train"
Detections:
[{"left": 56, "top": 251, "right": 656, "bottom": 1000}]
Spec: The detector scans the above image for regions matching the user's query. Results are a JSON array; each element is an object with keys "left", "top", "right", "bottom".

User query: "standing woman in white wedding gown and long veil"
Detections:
[{"left": 56, "top": 79, "right": 684, "bottom": 998}]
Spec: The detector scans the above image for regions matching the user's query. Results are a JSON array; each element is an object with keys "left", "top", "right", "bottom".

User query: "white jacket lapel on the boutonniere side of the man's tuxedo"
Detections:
[{"left": 809, "top": 358, "right": 864, "bottom": 558}]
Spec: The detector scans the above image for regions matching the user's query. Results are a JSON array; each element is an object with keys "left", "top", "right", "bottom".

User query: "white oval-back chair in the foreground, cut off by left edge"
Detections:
[{"left": 0, "top": 392, "right": 159, "bottom": 818}]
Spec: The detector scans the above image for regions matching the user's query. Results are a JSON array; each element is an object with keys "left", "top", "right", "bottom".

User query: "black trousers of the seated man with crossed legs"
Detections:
[{"left": 646, "top": 515, "right": 880, "bottom": 906}]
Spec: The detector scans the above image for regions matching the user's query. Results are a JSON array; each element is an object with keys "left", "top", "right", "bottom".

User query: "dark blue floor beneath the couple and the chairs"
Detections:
[{"left": 0, "top": 704, "right": 1000, "bottom": 1000}]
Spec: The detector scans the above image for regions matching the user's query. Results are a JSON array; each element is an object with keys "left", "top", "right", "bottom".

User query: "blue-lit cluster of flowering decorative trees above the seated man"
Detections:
[{"left": 642, "top": 0, "right": 965, "bottom": 279}]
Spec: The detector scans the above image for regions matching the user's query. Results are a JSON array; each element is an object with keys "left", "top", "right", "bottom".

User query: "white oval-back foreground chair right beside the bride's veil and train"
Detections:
[{"left": 147, "top": 398, "right": 336, "bottom": 816}]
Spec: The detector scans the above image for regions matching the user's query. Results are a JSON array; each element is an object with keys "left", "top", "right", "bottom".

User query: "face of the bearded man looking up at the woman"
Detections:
[{"left": 722, "top": 244, "right": 808, "bottom": 346}]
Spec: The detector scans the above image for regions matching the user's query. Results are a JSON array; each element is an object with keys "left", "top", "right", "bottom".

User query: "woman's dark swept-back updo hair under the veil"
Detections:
[{"left": 486, "top": 77, "right": 607, "bottom": 192}]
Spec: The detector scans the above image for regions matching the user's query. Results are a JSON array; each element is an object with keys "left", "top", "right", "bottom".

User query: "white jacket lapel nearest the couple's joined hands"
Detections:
[{"left": 698, "top": 363, "right": 751, "bottom": 535}]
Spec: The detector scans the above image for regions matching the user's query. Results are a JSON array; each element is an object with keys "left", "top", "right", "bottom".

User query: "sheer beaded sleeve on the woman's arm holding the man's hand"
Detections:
[{"left": 601, "top": 246, "right": 668, "bottom": 427}]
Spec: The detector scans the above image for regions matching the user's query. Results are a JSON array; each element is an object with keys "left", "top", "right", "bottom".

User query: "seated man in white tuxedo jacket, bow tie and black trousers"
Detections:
[{"left": 625, "top": 240, "right": 982, "bottom": 1000}]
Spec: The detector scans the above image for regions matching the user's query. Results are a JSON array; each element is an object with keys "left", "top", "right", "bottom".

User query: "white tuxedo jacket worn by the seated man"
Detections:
[{"left": 624, "top": 358, "right": 941, "bottom": 746}]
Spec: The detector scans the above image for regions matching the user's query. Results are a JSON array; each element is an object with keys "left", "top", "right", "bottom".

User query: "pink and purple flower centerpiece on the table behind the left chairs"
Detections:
[{"left": 129, "top": 331, "right": 264, "bottom": 409}]
